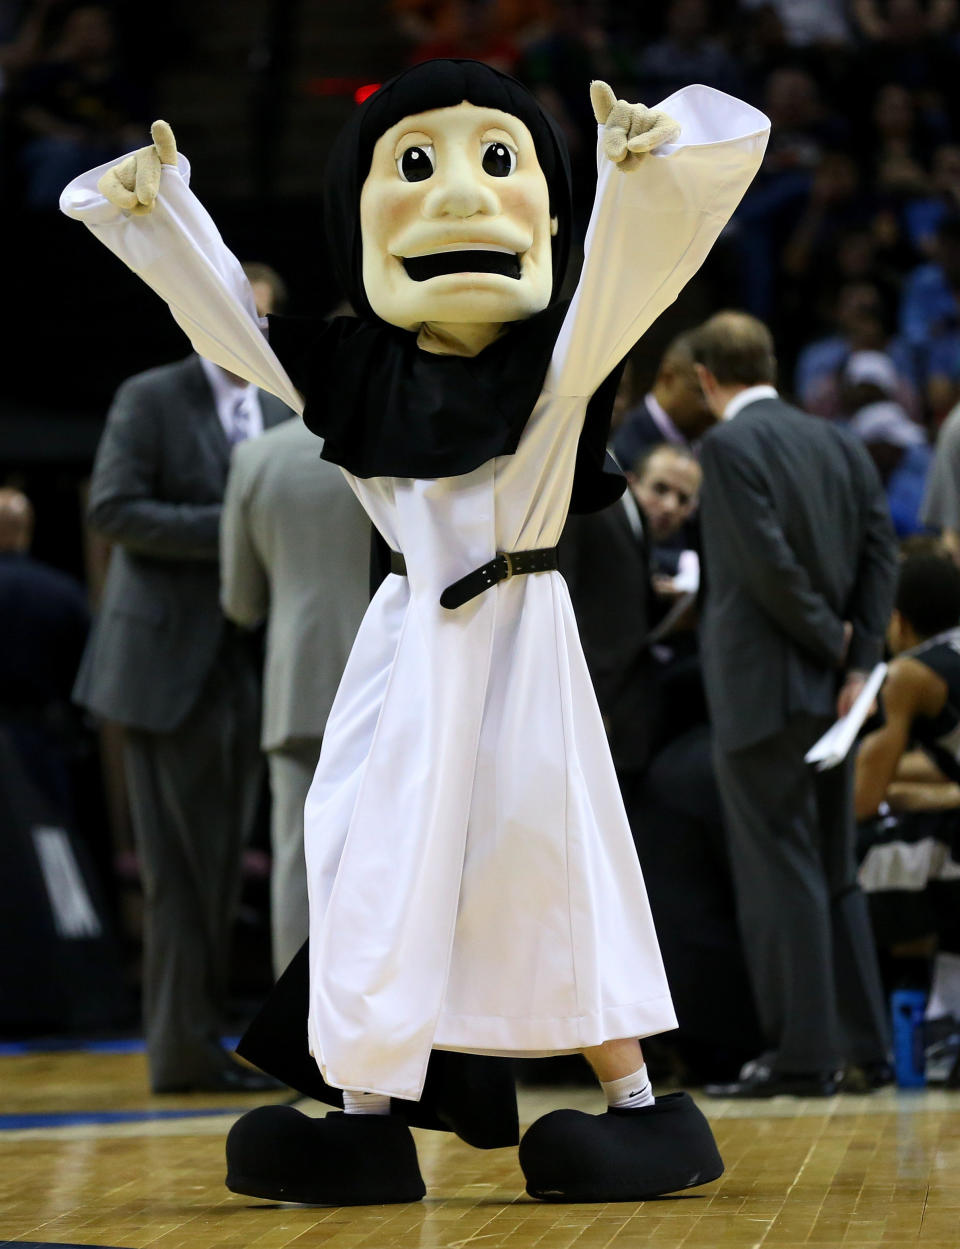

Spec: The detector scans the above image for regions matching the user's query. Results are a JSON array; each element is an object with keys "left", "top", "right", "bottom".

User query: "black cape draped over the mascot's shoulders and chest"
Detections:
[{"left": 270, "top": 304, "right": 625, "bottom": 512}]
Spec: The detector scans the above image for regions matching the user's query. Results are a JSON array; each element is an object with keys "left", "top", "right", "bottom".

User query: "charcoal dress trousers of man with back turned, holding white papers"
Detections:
[{"left": 714, "top": 714, "right": 889, "bottom": 1073}]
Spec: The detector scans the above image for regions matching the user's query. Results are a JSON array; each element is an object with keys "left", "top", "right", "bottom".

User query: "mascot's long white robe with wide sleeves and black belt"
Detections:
[{"left": 61, "top": 86, "right": 769, "bottom": 1099}]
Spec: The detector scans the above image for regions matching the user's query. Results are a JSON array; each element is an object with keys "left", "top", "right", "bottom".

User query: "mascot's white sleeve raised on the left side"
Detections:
[{"left": 60, "top": 154, "right": 303, "bottom": 412}]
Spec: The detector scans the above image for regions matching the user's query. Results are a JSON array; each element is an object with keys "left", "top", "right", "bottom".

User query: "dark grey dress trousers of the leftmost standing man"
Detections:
[{"left": 124, "top": 628, "right": 262, "bottom": 1090}]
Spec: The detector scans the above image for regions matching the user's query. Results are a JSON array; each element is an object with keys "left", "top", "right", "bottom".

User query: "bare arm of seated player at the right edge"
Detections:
[{"left": 854, "top": 658, "right": 931, "bottom": 819}]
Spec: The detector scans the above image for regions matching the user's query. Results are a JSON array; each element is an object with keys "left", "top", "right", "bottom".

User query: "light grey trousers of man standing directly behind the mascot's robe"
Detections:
[{"left": 267, "top": 737, "right": 321, "bottom": 978}]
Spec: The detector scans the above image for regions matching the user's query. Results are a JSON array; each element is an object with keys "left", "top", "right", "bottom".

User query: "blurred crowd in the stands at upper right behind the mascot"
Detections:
[{"left": 392, "top": 0, "right": 960, "bottom": 536}]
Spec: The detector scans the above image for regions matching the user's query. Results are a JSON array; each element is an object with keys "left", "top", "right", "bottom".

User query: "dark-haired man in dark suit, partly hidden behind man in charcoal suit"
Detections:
[{"left": 612, "top": 333, "right": 714, "bottom": 471}]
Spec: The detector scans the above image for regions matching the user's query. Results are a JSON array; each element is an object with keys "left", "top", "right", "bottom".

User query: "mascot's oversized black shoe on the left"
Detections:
[{"left": 226, "top": 1105, "right": 427, "bottom": 1205}]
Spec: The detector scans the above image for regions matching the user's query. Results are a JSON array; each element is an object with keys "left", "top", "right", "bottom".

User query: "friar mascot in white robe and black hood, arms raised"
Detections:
[{"left": 61, "top": 60, "right": 769, "bottom": 1205}]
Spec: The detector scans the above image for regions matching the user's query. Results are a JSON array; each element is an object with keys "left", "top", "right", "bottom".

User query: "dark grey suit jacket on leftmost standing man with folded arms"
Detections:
[{"left": 74, "top": 356, "right": 292, "bottom": 733}]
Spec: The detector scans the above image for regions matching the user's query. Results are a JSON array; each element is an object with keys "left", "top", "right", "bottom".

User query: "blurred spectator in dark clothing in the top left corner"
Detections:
[{"left": 12, "top": 5, "right": 150, "bottom": 207}]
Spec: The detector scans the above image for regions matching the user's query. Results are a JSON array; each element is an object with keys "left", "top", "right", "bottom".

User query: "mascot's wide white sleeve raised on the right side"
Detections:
[{"left": 544, "top": 86, "right": 770, "bottom": 395}]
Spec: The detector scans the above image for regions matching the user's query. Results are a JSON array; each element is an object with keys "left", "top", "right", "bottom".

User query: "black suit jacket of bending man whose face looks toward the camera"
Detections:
[{"left": 559, "top": 500, "right": 658, "bottom": 772}]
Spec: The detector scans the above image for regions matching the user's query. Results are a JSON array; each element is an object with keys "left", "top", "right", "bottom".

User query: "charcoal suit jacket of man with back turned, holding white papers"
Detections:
[{"left": 700, "top": 398, "right": 896, "bottom": 751}]
